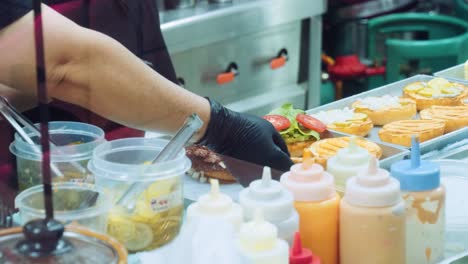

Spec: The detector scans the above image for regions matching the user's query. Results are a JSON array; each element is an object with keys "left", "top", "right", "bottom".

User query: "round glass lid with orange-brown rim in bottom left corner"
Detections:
[{"left": 0, "top": 226, "right": 127, "bottom": 264}]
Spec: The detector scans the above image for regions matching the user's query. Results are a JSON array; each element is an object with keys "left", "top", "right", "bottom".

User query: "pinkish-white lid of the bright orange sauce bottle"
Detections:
[{"left": 281, "top": 164, "right": 335, "bottom": 202}]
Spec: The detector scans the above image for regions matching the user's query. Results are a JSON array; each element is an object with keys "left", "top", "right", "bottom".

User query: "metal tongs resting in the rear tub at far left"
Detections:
[{"left": 0, "top": 96, "right": 86, "bottom": 177}]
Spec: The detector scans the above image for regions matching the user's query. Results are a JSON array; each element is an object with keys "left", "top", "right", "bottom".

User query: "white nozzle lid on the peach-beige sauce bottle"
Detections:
[{"left": 344, "top": 157, "right": 401, "bottom": 207}]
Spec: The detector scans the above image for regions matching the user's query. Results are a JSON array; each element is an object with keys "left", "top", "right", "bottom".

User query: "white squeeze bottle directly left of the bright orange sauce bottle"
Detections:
[{"left": 239, "top": 167, "right": 299, "bottom": 245}]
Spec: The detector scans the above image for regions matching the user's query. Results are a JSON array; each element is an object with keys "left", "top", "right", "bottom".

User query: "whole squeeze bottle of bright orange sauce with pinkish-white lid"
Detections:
[{"left": 280, "top": 152, "right": 340, "bottom": 264}]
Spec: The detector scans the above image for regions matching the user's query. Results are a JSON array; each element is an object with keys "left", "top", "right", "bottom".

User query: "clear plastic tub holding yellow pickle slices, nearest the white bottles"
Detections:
[{"left": 88, "top": 138, "right": 191, "bottom": 252}]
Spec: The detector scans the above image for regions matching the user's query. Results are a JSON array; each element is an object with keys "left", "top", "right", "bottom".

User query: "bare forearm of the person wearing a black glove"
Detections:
[{"left": 0, "top": 4, "right": 210, "bottom": 139}]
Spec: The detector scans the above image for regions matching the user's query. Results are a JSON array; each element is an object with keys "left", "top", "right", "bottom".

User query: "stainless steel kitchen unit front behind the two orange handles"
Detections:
[{"left": 160, "top": 0, "right": 327, "bottom": 114}]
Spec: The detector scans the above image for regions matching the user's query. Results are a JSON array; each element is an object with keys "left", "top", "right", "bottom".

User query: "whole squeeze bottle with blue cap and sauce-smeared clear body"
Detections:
[{"left": 391, "top": 137, "right": 445, "bottom": 263}]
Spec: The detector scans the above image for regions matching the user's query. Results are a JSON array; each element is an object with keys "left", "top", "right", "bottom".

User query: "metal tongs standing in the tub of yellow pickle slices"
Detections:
[{"left": 117, "top": 113, "right": 203, "bottom": 212}]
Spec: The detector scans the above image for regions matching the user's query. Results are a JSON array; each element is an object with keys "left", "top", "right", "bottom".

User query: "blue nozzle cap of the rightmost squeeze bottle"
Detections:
[{"left": 390, "top": 137, "right": 440, "bottom": 191}]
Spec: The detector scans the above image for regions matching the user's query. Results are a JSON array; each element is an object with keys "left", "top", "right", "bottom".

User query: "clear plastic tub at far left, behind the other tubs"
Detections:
[{"left": 10, "top": 122, "right": 105, "bottom": 190}]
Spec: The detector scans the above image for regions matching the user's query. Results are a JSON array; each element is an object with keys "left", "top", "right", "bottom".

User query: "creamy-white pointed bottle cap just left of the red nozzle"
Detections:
[{"left": 239, "top": 209, "right": 278, "bottom": 252}]
